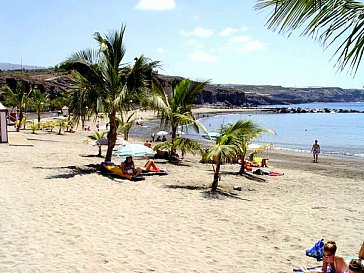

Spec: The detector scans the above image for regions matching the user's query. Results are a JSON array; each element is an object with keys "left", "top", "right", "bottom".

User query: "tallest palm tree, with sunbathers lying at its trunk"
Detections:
[{"left": 62, "top": 25, "right": 158, "bottom": 161}]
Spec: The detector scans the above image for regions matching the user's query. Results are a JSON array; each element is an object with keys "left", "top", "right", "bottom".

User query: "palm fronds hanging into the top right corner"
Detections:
[{"left": 256, "top": 0, "right": 364, "bottom": 74}]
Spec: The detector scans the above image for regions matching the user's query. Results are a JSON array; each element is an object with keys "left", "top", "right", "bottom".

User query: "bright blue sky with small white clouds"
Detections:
[{"left": 0, "top": 0, "right": 364, "bottom": 89}]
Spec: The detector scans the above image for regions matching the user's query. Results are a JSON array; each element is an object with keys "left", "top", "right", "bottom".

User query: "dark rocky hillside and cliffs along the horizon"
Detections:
[{"left": 0, "top": 69, "right": 364, "bottom": 107}]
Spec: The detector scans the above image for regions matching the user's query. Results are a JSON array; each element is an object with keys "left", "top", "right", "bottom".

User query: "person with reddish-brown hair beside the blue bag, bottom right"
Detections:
[{"left": 319, "top": 241, "right": 348, "bottom": 273}]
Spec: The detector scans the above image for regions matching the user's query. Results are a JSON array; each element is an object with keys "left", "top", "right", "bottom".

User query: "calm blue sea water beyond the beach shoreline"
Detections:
[{"left": 193, "top": 102, "right": 364, "bottom": 160}]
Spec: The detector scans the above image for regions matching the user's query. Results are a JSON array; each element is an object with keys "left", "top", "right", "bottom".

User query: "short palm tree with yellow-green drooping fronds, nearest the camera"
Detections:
[{"left": 204, "top": 120, "right": 270, "bottom": 192}]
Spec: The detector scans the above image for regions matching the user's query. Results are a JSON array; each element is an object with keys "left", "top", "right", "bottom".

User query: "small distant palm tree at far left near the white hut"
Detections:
[{"left": 2, "top": 81, "right": 29, "bottom": 132}]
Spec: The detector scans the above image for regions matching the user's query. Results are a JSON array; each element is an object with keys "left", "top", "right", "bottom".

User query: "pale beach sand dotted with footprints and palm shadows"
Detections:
[{"left": 0, "top": 110, "right": 364, "bottom": 273}]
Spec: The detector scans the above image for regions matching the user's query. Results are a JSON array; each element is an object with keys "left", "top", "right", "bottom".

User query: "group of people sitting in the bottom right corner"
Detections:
[{"left": 319, "top": 241, "right": 364, "bottom": 273}]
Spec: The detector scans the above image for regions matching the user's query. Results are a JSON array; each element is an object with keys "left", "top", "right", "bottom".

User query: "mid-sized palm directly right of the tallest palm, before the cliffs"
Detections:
[{"left": 152, "top": 79, "right": 209, "bottom": 141}]
